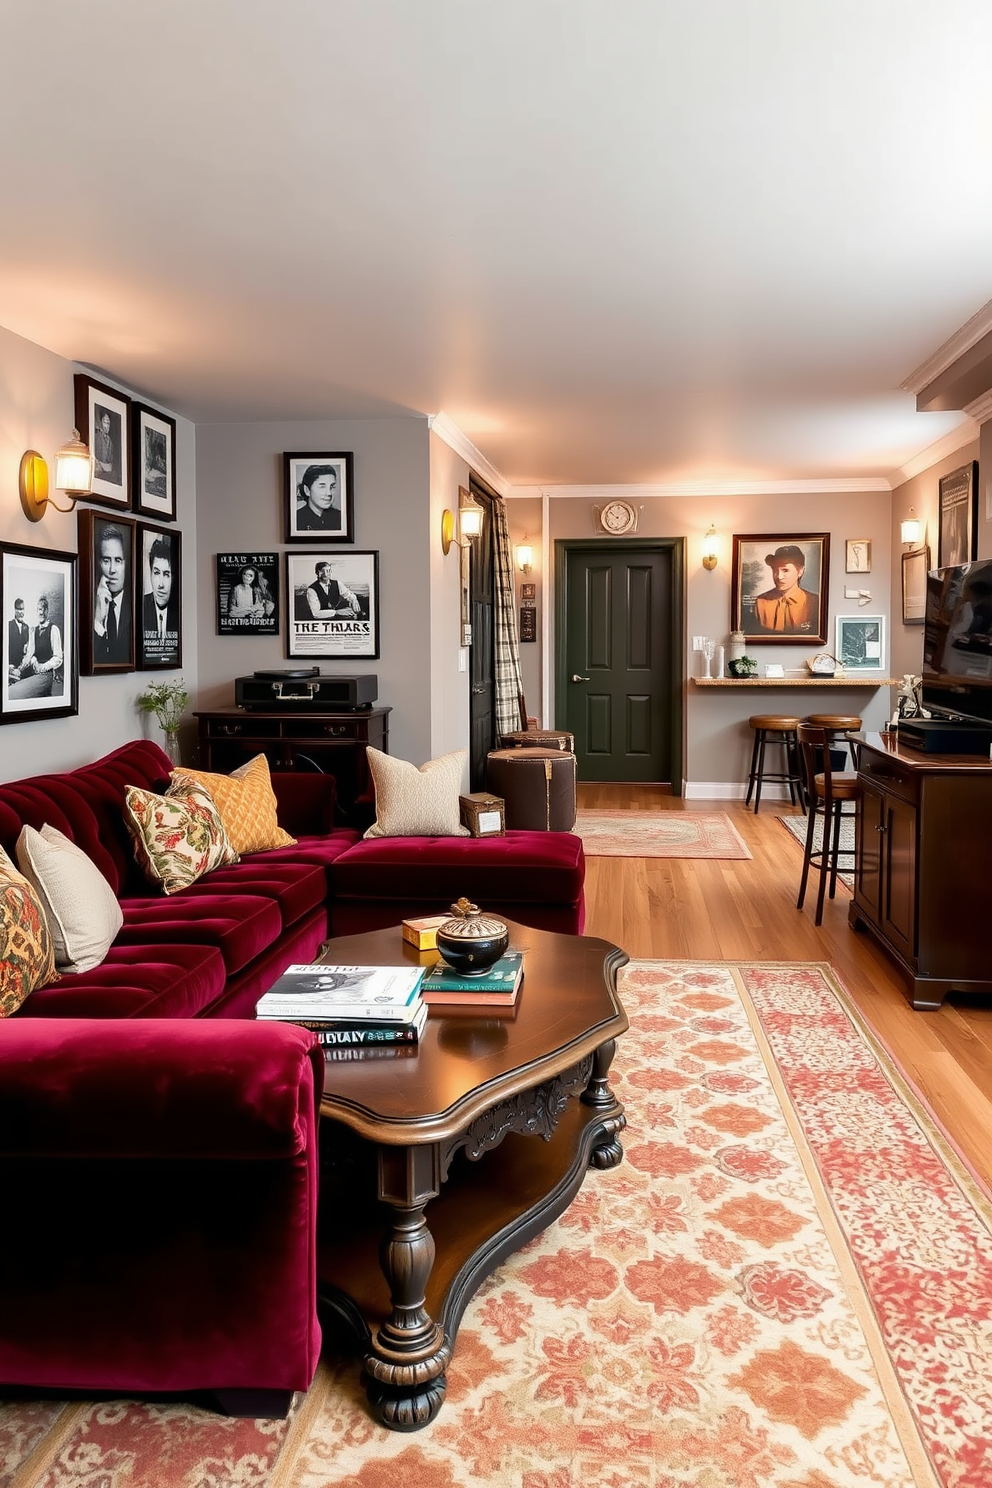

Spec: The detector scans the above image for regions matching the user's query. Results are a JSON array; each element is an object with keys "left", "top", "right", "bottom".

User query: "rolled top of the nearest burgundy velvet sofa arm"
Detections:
[{"left": 0, "top": 1018, "right": 323, "bottom": 1159}]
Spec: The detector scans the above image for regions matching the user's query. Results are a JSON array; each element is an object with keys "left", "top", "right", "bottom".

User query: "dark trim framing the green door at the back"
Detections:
[{"left": 555, "top": 537, "right": 686, "bottom": 796}]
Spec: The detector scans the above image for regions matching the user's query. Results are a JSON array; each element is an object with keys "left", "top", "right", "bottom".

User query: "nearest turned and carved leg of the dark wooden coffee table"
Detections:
[{"left": 364, "top": 1144, "right": 451, "bottom": 1431}]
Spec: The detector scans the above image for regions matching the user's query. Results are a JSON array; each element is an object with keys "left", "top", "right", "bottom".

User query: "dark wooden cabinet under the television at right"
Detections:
[{"left": 849, "top": 735, "right": 992, "bottom": 1009}]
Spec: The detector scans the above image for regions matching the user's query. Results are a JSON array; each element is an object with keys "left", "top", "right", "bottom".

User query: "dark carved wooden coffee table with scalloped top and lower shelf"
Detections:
[{"left": 318, "top": 923, "right": 628, "bottom": 1431}]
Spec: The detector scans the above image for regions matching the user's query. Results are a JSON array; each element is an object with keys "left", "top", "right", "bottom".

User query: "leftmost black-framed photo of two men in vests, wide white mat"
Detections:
[{"left": 0, "top": 543, "right": 79, "bottom": 723}]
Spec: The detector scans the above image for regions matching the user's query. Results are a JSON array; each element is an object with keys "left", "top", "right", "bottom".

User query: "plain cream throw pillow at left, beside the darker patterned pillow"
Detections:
[{"left": 18, "top": 823, "right": 123, "bottom": 972}]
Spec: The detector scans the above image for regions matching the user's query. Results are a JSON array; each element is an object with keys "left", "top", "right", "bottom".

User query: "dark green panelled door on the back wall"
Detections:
[{"left": 556, "top": 539, "right": 683, "bottom": 792}]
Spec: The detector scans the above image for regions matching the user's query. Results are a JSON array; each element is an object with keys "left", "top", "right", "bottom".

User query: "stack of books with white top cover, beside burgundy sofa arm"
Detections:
[{"left": 254, "top": 961, "right": 427, "bottom": 1051}]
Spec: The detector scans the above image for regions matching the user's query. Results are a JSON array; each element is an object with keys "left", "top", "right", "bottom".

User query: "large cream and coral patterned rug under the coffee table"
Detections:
[{"left": 0, "top": 961, "right": 992, "bottom": 1488}]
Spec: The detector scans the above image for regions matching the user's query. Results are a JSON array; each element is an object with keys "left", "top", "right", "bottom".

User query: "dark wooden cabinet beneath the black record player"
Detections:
[{"left": 196, "top": 708, "right": 393, "bottom": 827}]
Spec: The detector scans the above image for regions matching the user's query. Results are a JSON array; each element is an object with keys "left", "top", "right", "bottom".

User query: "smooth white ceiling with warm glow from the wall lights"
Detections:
[{"left": 0, "top": 0, "right": 992, "bottom": 485}]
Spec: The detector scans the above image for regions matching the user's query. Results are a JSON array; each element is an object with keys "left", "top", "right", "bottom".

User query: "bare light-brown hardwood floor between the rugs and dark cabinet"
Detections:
[{"left": 579, "top": 784, "right": 992, "bottom": 1186}]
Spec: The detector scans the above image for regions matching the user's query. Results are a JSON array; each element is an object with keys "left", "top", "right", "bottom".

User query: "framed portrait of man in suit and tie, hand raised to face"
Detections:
[{"left": 76, "top": 509, "right": 135, "bottom": 677}]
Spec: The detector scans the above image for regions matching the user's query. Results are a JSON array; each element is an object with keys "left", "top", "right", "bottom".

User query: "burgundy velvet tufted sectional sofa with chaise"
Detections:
[{"left": 0, "top": 741, "right": 584, "bottom": 1415}]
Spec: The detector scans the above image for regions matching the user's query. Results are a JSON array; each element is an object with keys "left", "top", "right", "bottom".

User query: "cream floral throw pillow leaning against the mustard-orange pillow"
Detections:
[{"left": 125, "top": 781, "right": 238, "bottom": 894}]
